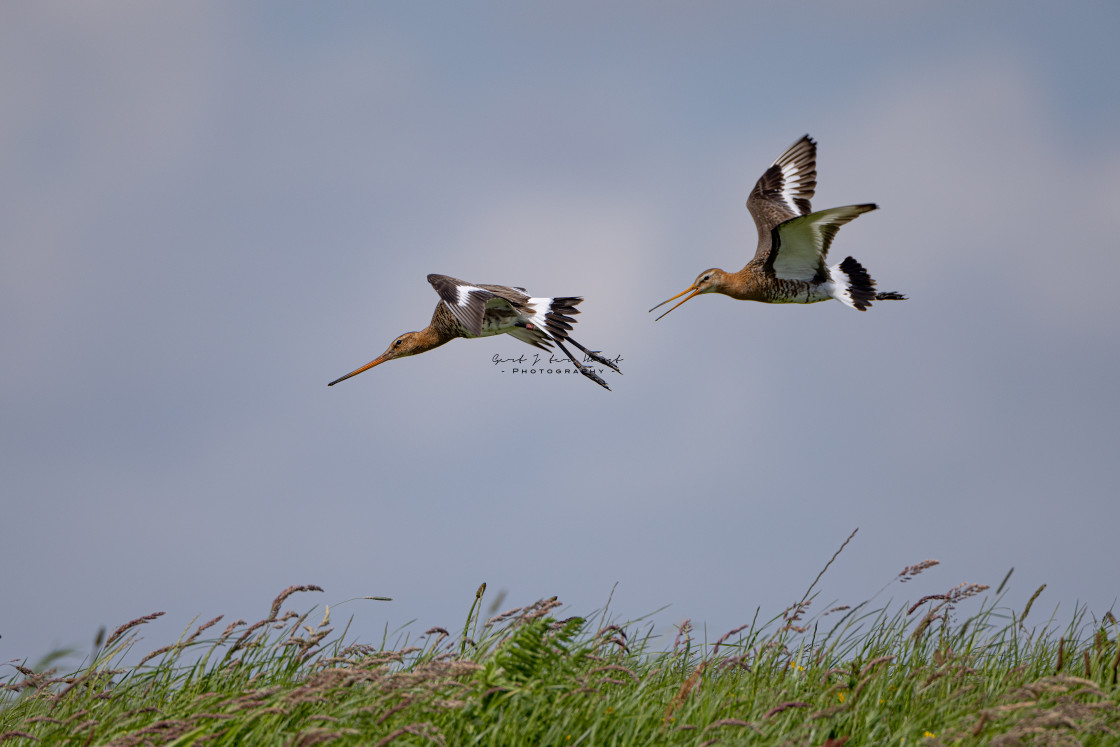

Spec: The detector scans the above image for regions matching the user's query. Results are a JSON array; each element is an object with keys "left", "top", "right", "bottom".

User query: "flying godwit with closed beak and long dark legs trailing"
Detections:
[{"left": 327, "top": 274, "right": 622, "bottom": 390}]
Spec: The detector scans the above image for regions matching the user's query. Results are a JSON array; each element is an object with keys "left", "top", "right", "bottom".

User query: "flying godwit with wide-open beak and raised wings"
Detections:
[{"left": 650, "top": 134, "right": 906, "bottom": 319}]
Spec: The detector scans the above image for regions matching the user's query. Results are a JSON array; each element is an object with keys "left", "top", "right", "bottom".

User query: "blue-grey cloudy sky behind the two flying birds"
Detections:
[{"left": 0, "top": 0, "right": 1120, "bottom": 661}]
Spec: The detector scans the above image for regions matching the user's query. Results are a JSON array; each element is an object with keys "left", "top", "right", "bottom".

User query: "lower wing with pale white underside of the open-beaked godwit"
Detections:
[{"left": 763, "top": 204, "right": 878, "bottom": 282}]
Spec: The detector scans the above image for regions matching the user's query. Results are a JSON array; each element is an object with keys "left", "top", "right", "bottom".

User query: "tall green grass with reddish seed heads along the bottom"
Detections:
[{"left": 0, "top": 538, "right": 1120, "bottom": 747}]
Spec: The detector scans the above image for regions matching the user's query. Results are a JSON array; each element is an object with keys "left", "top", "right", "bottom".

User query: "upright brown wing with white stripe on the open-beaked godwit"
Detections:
[{"left": 747, "top": 134, "right": 816, "bottom": 235}]
